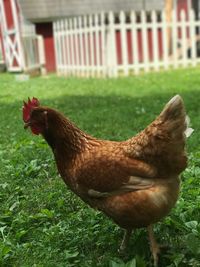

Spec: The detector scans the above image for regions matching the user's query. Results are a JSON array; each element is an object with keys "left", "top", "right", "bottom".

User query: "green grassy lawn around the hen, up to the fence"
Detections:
[{"left": 0, "top": 68, "right": 200, "bottom": 267}]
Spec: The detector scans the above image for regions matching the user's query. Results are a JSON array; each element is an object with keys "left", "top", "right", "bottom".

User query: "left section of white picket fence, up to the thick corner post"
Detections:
[{"left": 53, "top": 14, "right": 106, "bottom": 76}]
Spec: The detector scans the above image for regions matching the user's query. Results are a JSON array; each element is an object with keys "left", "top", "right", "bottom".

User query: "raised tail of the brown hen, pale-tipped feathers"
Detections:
[{"left": 129, "top": 95, "right": 193, "bottom": 176}]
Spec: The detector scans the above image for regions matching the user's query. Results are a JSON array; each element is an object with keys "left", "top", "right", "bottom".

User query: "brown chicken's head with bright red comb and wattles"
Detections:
[{"left": 23, "top": 97, "right": 47, "bottom": 135}]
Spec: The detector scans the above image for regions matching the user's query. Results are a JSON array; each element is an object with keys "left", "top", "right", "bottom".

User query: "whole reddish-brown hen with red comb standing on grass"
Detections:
[{"left": 23, "top": 95, "right": 192, "bottom": 266}]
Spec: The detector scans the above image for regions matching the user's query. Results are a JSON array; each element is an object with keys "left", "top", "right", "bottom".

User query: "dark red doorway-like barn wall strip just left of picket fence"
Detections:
[{"left": 36, "top": 22, "right": 56, "bottom": 72}]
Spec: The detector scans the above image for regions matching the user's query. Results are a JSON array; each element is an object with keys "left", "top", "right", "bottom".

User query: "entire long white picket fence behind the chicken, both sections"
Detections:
[{"left": 53, "top": 9, "right": 200, "bottom": 77}]
